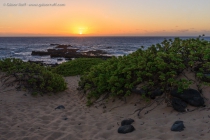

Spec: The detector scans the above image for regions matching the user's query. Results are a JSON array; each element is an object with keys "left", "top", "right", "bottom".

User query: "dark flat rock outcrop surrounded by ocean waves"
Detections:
[{"left": 31, "top": 44, "right": 111, "bottom": 58}]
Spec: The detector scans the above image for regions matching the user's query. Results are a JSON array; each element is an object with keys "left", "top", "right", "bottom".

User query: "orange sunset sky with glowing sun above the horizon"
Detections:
[{"left": 0, "top": 0, "right": 210, "bottom": 36}]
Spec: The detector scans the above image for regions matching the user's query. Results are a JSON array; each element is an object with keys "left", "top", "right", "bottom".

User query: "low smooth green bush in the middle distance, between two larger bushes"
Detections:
[{"left": 53, "top": 58, "right": 104, "bottom": 76}]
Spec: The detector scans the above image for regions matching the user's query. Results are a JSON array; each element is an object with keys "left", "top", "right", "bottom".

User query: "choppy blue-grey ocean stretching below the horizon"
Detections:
[{"left": 0, "top": 37, "right": 210, "bottom": 64}]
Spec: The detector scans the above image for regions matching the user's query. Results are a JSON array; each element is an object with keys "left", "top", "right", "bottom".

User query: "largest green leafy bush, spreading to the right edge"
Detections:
[{"left": 79, "top": 37, "right": 210, "bottom": 104}]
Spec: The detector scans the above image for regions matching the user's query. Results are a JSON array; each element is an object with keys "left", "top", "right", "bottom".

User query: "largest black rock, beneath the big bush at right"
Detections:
[{"left": 171, "top": 89, "right": 204, "bottom": 107}]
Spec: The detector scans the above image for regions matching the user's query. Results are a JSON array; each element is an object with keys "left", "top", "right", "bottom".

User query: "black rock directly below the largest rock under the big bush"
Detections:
[{"left": 171, "top": 98, "right": 187, "bottom": 112}]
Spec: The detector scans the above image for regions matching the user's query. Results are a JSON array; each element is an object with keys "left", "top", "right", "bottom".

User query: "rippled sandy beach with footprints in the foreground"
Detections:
[{"left": 0, "top": 76, "right": 210, "bottom": 140}]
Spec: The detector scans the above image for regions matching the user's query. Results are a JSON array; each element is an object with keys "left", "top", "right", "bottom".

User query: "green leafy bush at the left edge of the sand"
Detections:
[{"left": 0, "top": 58, "right": 67, "bottom": 93}]
